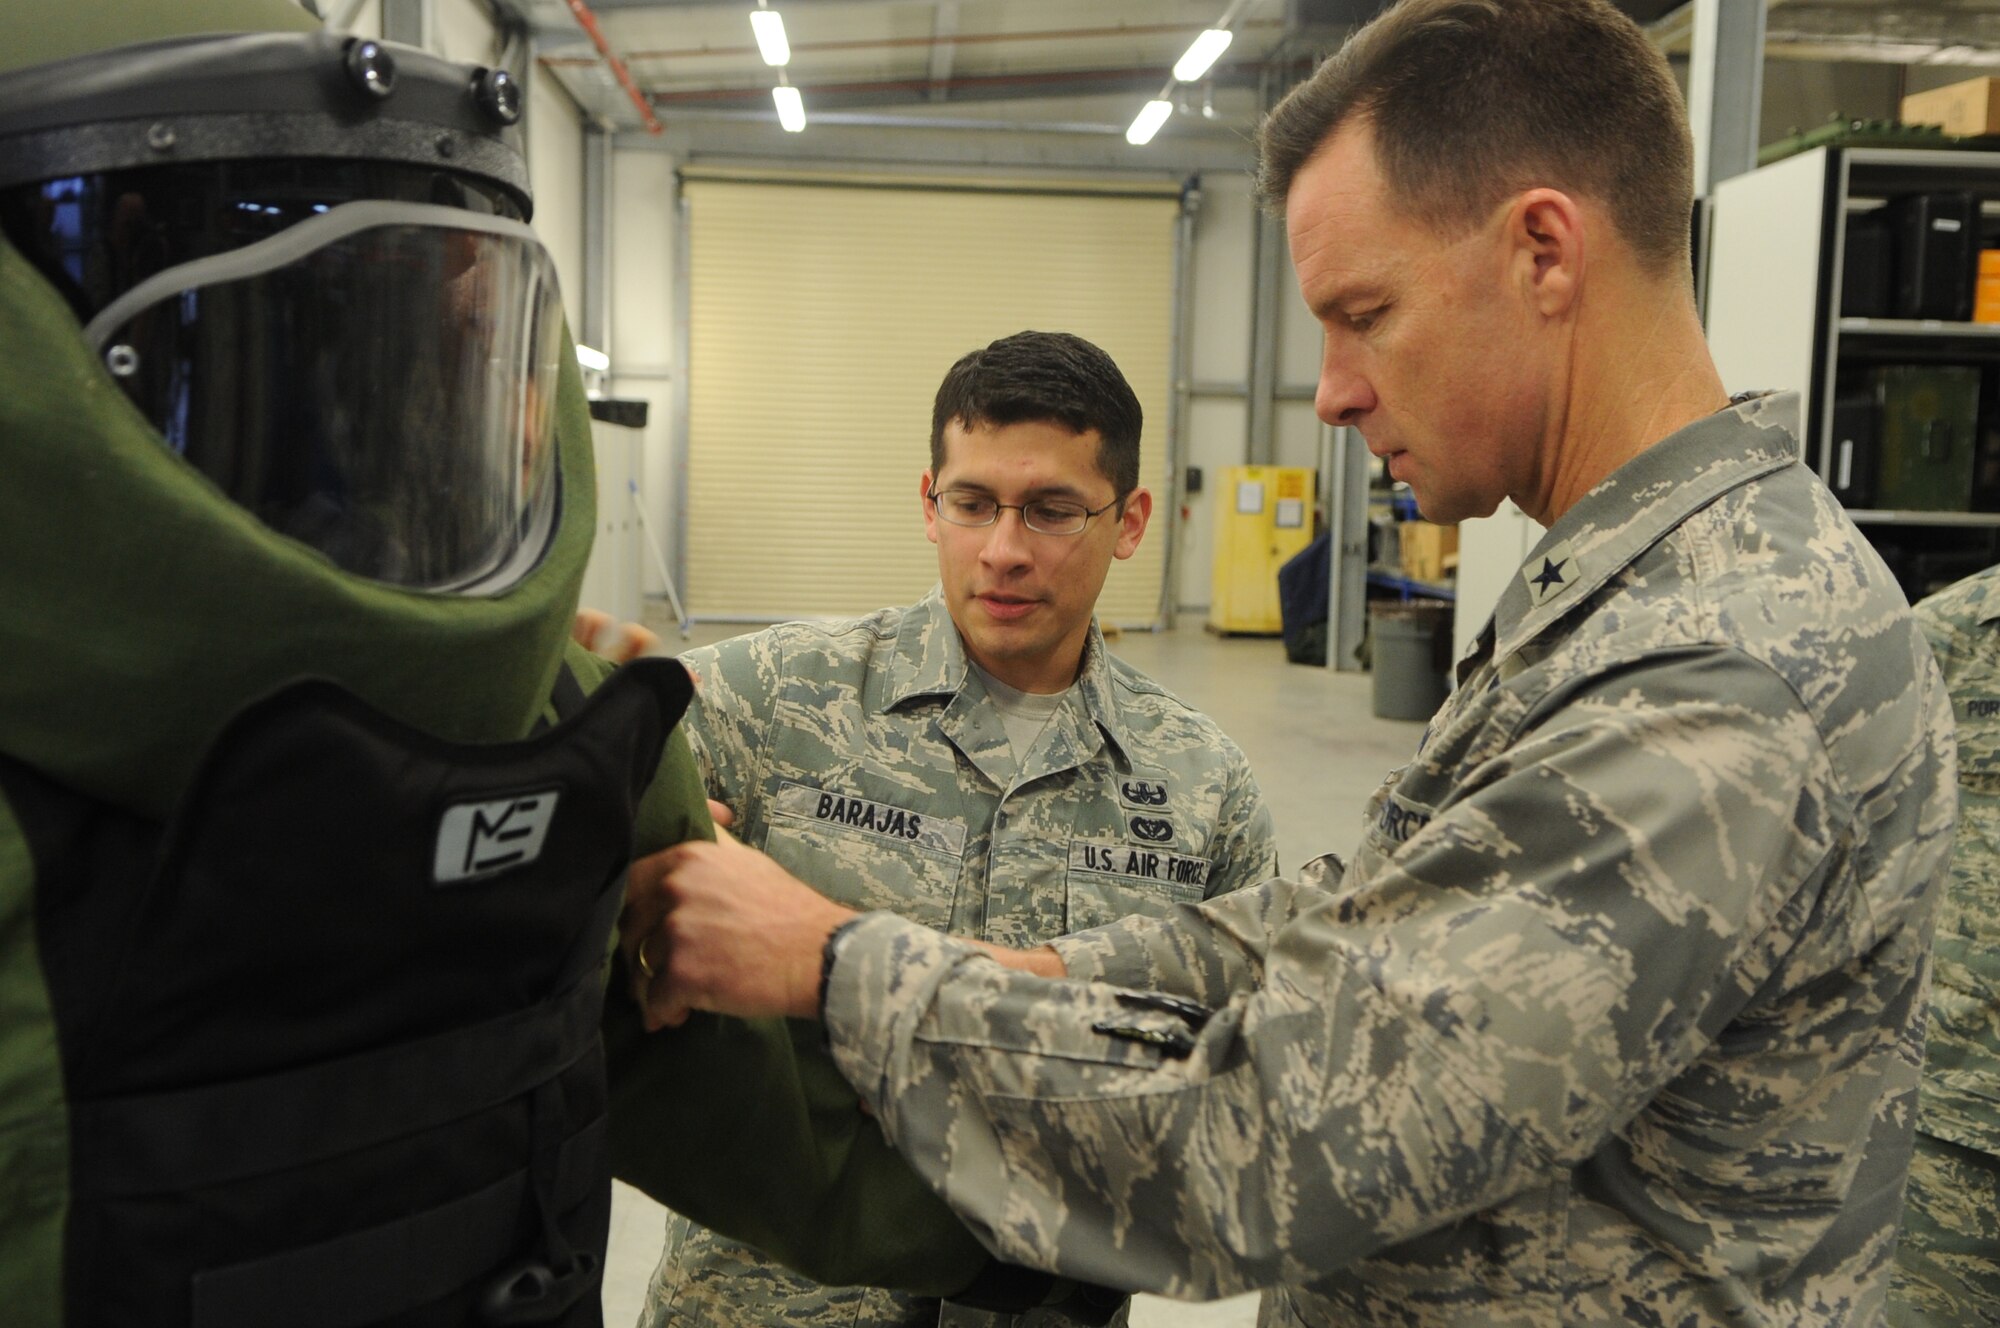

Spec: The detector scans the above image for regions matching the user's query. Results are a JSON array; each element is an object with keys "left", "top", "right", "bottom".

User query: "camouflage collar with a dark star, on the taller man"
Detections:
[{"left": 1460, "top": 392, "right": 1798, "bottom": 672}]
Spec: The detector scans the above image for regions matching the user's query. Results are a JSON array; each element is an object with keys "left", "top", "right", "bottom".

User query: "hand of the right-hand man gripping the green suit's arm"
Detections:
[{"left": 620, "top": 824, "right": 856, "bottom": 1028}]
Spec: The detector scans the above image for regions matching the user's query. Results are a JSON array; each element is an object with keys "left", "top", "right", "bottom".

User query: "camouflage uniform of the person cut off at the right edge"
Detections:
[{"left": 1890, "top": 568, "right": 2000, "bottom": 1328}]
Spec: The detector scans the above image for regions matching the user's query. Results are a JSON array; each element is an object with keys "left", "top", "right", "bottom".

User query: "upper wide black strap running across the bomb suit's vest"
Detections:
[{"left": 72, "top": 972, "right": 602, "bottom": 1196}]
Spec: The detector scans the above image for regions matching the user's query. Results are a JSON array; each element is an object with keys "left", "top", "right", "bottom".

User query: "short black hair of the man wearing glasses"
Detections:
[{"left": 930, "top": 332, "right": 1144, "bottom": 502}]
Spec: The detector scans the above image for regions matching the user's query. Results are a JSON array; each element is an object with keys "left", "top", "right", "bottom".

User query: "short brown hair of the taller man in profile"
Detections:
[{"left": 1258, "top": 0, "right": 1694, "bottom": 274}]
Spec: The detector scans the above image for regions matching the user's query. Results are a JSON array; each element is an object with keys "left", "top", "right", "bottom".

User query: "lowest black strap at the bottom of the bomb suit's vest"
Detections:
[{"left": 190, "top": 1116, "right": 608, "bottom": 1328}]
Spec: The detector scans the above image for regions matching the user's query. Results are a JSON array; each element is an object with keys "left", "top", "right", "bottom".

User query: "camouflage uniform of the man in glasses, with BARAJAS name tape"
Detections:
[{"left": 646, "top": 592, "right": 1278, "bottom": 1328}]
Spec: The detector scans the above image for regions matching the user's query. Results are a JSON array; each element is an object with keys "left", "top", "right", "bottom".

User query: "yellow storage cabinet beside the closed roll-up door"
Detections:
[{"left": 1208, "top": 466, "right": 1312, "bottom": 636}]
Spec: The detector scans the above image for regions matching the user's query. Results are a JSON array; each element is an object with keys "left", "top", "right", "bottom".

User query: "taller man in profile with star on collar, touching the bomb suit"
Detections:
[{"left": 636, "top": 0, "right": 1956, "bottom": 1328}]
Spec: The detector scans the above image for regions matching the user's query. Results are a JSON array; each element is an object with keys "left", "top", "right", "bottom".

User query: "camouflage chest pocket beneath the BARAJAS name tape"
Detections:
[{"left": 764, "top": 784, "right": 966, "bottom": 930}]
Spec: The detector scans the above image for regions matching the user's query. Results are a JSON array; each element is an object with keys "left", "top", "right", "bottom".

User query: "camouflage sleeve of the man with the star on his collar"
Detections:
[{"left": 826, "top": 650, "right": 1840, "bottom": 1298}]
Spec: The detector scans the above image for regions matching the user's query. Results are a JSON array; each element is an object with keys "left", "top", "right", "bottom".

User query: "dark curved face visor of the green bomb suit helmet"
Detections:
[{"left": 84, "top": 202, "right": 562, "bottom": 594}]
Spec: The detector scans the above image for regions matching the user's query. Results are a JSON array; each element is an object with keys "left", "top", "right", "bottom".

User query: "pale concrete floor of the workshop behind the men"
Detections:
[{"left": 604, "top": 604, "right": 1424, "bottom": 1328}]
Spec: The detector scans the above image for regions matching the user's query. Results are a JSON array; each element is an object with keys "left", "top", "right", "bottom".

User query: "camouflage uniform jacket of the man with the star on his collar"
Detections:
[{"left": 808, "top": 398, "right": 1956, "bottom": 1328}]
